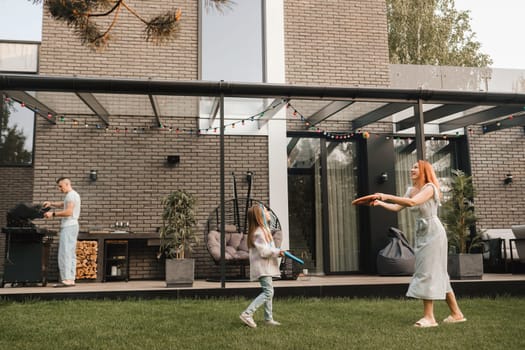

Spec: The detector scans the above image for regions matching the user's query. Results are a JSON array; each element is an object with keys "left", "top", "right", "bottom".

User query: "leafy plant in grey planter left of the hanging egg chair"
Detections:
[{"left": 158, "top": 190, "right": 198, "bottom": 287}]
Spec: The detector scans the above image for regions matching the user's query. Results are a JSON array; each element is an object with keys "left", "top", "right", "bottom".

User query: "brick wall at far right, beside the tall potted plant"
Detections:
[{"left": 469, "top": 126, "right": 525, "bottom": 229}]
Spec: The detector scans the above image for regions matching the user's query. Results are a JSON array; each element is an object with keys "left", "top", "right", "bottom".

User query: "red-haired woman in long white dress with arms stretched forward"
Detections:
[{"left": 371, "top": 160, "right": 467, "bottom": 328}]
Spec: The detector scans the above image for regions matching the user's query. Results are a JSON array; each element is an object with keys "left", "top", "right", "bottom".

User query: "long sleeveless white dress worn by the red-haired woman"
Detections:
[{"left": 406, "top": 183, "right": 452, "bottom": 300}]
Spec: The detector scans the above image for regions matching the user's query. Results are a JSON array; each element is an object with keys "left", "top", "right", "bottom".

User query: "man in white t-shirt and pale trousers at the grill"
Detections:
[{"left": 43, "top": 177, "right": 80, "bottom": 287}]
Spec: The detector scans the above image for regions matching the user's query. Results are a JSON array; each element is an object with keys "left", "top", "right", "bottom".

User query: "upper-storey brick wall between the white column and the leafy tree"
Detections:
[{"left": 284, "top": 0, "right": 389, "bottom": 86}]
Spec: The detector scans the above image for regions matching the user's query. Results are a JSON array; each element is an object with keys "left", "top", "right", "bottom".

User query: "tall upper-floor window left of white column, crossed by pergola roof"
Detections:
[{"left": 199, "top": 0, "right": 271, "bottom": 134}]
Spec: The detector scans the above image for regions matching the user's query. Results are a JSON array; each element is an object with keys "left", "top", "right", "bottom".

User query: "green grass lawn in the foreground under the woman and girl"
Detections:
[{"left": 0, "top": 297, "right": 525, "bottom": 350}]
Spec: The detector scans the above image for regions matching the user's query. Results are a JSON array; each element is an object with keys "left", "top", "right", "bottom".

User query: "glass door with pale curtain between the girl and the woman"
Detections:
[{"left": 288, "top": 137, "right": 359, "bottom": 273}]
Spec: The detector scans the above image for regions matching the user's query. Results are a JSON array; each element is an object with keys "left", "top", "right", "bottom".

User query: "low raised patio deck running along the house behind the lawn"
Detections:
[{"left": 0, "top": 273, "right": 525, "bottom": 300}]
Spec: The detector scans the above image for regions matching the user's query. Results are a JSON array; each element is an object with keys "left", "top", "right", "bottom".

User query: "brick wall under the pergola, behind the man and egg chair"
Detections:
[{"left": 34, "top": 116, "right": 268, "bottom": 278}]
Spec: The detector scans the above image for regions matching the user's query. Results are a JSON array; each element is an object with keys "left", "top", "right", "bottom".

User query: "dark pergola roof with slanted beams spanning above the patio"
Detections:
[{"left": 0, "top": 74, "right": 525, "bottom": 155}]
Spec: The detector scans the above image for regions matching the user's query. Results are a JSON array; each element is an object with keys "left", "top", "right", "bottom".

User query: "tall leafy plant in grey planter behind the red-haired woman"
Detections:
[{"left": 443, "top": 170, "right": 483, "bottom": 279}]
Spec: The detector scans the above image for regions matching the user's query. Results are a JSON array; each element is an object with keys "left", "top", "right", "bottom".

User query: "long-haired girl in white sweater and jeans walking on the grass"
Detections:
[{"left": 240, "top": 204, "right": 284, "bottom": 328}]
